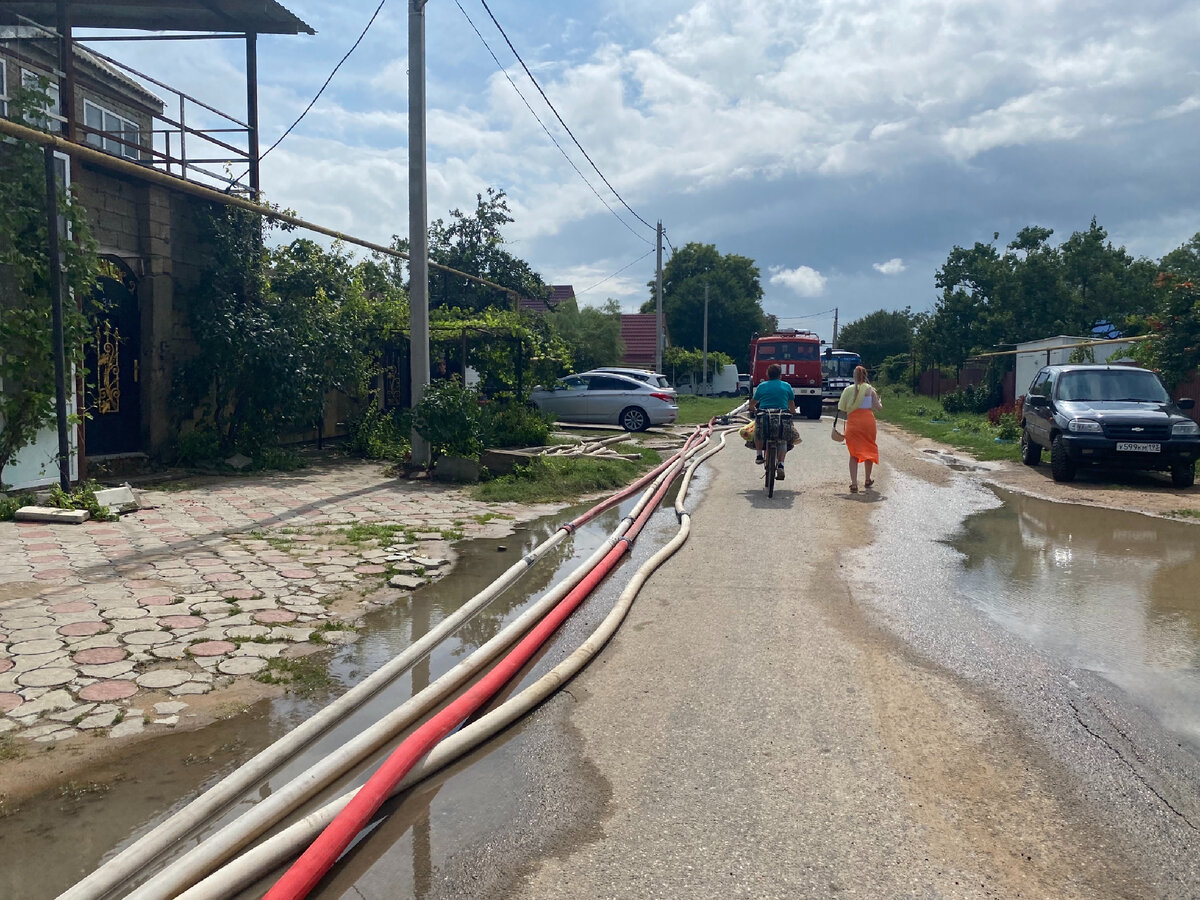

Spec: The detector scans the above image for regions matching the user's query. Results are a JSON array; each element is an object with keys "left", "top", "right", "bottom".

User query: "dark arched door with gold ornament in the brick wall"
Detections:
[{"left": 84, "top": 260, "right": 142, "bottom": 457}]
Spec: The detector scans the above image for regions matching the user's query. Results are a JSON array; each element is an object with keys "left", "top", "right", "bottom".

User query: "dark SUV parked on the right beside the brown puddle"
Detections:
[{"left": 1021, "top": 366, "right": 1200, "bottom": 487}]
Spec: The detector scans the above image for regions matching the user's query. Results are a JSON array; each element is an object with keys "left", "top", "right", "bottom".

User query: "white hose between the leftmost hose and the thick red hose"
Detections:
[{"left": 120, "top": 446, "right": 700, "bottom": 900}]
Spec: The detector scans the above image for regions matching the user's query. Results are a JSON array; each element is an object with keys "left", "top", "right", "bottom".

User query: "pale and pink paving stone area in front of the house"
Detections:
[{"left": 0, "top": 462, "right": 557, "bottom": 743}]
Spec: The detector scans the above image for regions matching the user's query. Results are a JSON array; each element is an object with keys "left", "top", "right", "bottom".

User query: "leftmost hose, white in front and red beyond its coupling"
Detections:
[{"left": 58, "top": 433, "right": 696, "bottom": 900}]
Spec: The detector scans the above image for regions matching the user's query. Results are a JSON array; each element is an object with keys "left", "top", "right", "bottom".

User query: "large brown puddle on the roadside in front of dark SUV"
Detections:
[{"left": 954, "top": 492, "right": 1200, "bottom": 749}]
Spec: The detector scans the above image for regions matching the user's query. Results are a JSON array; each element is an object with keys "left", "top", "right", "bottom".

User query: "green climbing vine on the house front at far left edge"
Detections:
[{"left": 0, "top": 79, "right": 98, "bottom": 485}]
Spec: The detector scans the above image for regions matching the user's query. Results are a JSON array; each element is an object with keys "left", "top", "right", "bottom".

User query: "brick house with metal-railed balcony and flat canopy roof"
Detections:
[{"left": 0, "top": 0, "right": 314, "bottom": 487}]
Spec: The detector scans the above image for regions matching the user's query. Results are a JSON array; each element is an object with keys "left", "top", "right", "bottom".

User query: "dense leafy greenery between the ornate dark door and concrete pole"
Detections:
[{"left": 174, "top": 213, "right": 408, "bottom": 455}]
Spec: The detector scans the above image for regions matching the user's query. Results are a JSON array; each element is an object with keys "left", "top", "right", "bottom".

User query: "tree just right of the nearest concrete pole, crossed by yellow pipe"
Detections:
[{"left": 392, "top": 187, "right": 550, "bottom": 311}]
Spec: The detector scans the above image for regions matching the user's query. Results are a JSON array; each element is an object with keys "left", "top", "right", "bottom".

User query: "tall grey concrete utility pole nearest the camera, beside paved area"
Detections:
[{"left": 408, "top": 0, "right": 430, "bottom": 467}]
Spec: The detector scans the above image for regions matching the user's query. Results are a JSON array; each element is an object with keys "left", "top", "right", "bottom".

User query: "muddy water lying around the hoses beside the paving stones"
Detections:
[{"left": 0, "top": 492, "right": 676, "bottom": 900}]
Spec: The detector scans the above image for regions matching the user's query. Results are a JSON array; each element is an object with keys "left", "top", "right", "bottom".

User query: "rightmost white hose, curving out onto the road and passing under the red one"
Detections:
[{"left": 178, "top": 430, "right": 732, "bottom": 900}]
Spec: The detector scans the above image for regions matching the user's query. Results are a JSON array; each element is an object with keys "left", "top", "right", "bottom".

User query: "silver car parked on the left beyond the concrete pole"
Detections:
[{"left": 530, "top": 372, "right": 679, "bottom": 431}]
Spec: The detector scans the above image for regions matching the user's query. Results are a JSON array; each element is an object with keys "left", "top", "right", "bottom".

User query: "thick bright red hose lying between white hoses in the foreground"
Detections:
[{"left": 264, "top": 448, "right": 691, "bottom": 900}]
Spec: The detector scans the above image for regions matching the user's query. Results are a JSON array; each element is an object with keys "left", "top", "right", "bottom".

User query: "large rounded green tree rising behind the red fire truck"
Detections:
[{"left": 642, "top": 242, "right": 774, "bottom": 371}]
